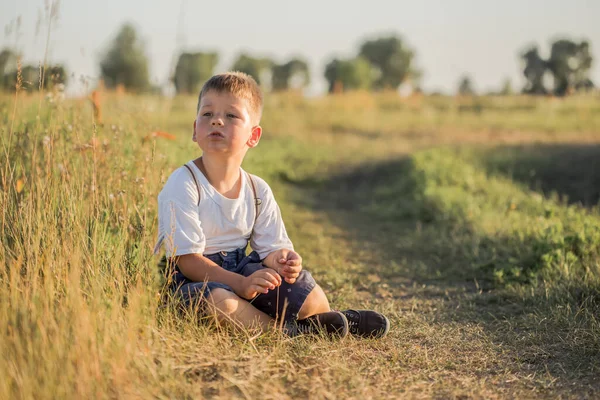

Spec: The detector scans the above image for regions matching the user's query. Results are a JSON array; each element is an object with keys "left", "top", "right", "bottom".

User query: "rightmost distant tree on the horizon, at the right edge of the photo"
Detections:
[{"left": 547, "top": 39, "right": 593, "bottom": 96}]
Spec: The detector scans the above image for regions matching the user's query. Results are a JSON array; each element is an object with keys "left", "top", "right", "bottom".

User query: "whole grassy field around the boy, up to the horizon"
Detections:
[{"left": 0, "top": 93, "right": 600, "bottom": 399}]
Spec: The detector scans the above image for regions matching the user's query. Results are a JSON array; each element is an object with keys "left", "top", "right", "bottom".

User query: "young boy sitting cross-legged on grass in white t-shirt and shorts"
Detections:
[{"left": 157, "top": 72, "right": 389, "bottom": 337}]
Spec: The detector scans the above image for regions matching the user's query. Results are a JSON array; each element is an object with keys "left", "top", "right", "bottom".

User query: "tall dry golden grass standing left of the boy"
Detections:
[{"left": 0, "top": 87, "right": 160, "bottom": 398}]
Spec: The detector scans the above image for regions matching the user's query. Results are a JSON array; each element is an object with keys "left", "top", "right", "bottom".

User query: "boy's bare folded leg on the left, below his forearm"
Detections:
[{"left": 207, "top": 288, "right": 273, "bottom": 331}]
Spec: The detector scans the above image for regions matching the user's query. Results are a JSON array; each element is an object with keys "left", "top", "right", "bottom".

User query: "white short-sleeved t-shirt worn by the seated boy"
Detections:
[{"left": 155, "top": 161, "right": 293, "bottom": 259}]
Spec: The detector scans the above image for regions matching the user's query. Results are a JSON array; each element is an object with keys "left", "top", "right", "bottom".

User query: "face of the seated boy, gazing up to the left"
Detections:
[{"left": 192, "top": 90, "right": 262, "bottom": 157}]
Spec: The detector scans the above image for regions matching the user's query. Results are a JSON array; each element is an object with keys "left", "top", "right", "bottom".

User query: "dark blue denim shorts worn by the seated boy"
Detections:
[{"left": 171, "top": 248, "right": 316, "bottom": 322}]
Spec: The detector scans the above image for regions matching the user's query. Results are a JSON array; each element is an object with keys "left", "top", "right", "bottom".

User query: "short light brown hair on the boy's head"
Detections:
[{"left": 196, "top": 71, "right": 263, "bottom": 124}]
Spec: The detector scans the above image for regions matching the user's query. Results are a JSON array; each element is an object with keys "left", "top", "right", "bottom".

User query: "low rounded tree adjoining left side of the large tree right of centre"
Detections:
[{"left": 325, "top": 57, "right": 373, "bottom": 93}]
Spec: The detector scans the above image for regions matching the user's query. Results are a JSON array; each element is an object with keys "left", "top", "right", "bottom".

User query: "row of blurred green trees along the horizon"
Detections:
[{"left": 0, "top": 24, "right": 594, "bottom": 96}]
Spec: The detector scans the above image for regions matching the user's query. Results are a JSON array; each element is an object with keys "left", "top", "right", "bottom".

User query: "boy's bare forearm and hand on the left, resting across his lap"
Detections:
[{"left": 176, "top": 253, "right": 281, "bottom": 299}]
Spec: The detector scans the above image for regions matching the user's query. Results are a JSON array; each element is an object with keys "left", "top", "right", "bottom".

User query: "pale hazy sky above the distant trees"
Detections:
[{"left": 0, "top": 0, "right": 600, "bottom": 95}]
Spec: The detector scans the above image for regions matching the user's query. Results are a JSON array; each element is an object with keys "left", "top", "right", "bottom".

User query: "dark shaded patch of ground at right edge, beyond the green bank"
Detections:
[{"left": 485, "top": 144, "right": 600, "bottom": 207}]
